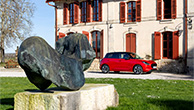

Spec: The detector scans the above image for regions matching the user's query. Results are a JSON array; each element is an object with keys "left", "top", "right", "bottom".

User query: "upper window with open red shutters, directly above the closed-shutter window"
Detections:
[{"left": 120, "top": 0, "right": 141, "bottom": 23}]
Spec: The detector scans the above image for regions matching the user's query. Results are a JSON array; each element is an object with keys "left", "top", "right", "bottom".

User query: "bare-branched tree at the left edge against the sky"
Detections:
[{"left": 0, "top": 0, "right": 35, "bottom": 62}]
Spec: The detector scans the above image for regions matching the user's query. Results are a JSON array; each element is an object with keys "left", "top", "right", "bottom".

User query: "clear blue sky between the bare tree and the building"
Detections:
[{"left": 5, "top": 0, "right": 55, "bottom": 53}]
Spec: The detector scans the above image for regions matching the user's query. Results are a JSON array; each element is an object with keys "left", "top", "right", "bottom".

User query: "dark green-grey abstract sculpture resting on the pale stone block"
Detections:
[{"left": 18, "top": 33, "right": 95, "bottom": 91}]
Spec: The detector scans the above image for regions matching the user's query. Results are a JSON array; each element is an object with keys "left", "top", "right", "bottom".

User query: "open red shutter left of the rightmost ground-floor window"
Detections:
[{"left": 154, "top": 32, "right": 161, "bottom": 59}]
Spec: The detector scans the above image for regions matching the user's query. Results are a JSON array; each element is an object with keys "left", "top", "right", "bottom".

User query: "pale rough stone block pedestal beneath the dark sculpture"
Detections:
[{"left": 14, "top": 84, "right": 119, "bottom": 110}]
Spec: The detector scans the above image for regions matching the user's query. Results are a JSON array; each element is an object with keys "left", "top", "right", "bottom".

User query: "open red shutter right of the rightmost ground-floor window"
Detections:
[{"left": 172, "top": 31, "right": 179, "bottom": 59}]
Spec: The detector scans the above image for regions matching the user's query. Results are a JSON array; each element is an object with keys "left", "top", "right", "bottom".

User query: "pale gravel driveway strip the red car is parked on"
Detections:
[{"left": 0, "top": 67, "right": 194, "bottom": 81}]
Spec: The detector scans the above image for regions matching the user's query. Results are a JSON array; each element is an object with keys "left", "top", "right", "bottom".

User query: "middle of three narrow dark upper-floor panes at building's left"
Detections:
[{"left": 81, "top": 2, "right": 87, "bottom": 22}]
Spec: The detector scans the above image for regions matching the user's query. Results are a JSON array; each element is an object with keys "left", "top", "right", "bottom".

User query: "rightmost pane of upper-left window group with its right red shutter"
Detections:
[{"left": 93, "top": 0, "right": 102, "bottom": 21}]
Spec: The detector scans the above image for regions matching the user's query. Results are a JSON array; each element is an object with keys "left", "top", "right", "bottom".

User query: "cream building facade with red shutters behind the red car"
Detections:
[{"left": 47, "top": 0, "right": 194, "bottom": 72}]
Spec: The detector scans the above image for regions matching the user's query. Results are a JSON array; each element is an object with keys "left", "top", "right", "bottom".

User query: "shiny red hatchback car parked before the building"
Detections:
[{"left": 100, "top": 52, "right": 157, "bottom": 74}]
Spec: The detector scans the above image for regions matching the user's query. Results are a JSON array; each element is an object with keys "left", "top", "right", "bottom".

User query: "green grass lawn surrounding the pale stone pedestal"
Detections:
[{"left": 0, "top": 78, "right": 194, "bottom": 110}]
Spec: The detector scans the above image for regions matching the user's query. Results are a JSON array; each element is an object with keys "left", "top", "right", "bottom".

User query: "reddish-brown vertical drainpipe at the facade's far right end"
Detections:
[{"left": 184, "top": 0, "right": 188, "bottom": 67}]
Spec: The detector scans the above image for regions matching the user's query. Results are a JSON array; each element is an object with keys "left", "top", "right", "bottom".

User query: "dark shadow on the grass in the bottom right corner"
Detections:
[{"left": 149, "top": 99, "right": 194, "bottom": 110}]
